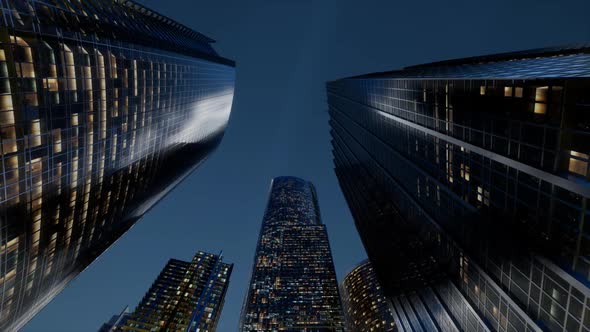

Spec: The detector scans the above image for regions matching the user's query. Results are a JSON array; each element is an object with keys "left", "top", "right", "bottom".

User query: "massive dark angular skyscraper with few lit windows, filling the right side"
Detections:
[{"left": 327, "top": 45, "right": 590, "bottom": 331}]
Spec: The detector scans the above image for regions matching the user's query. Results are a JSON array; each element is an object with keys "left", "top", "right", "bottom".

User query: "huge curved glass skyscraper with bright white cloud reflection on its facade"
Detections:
[{"left": 0, "top": 0, "right": 234, "bottom": 331}]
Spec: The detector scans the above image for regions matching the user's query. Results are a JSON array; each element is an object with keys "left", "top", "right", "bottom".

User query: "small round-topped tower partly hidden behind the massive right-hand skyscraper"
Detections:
[{"left": 340, "top": 260, "right": 397, "bottom": 332}]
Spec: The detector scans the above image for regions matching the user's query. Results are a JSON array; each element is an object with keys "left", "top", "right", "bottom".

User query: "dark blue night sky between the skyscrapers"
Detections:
[{"left": 24, "top": 0, "right": 590, "bottom": 332}]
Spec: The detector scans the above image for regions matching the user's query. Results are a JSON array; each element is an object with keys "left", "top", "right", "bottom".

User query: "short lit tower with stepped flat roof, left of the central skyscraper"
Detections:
[{"left": 100, "top": 251, "right": 233, "bottom": 332}]
